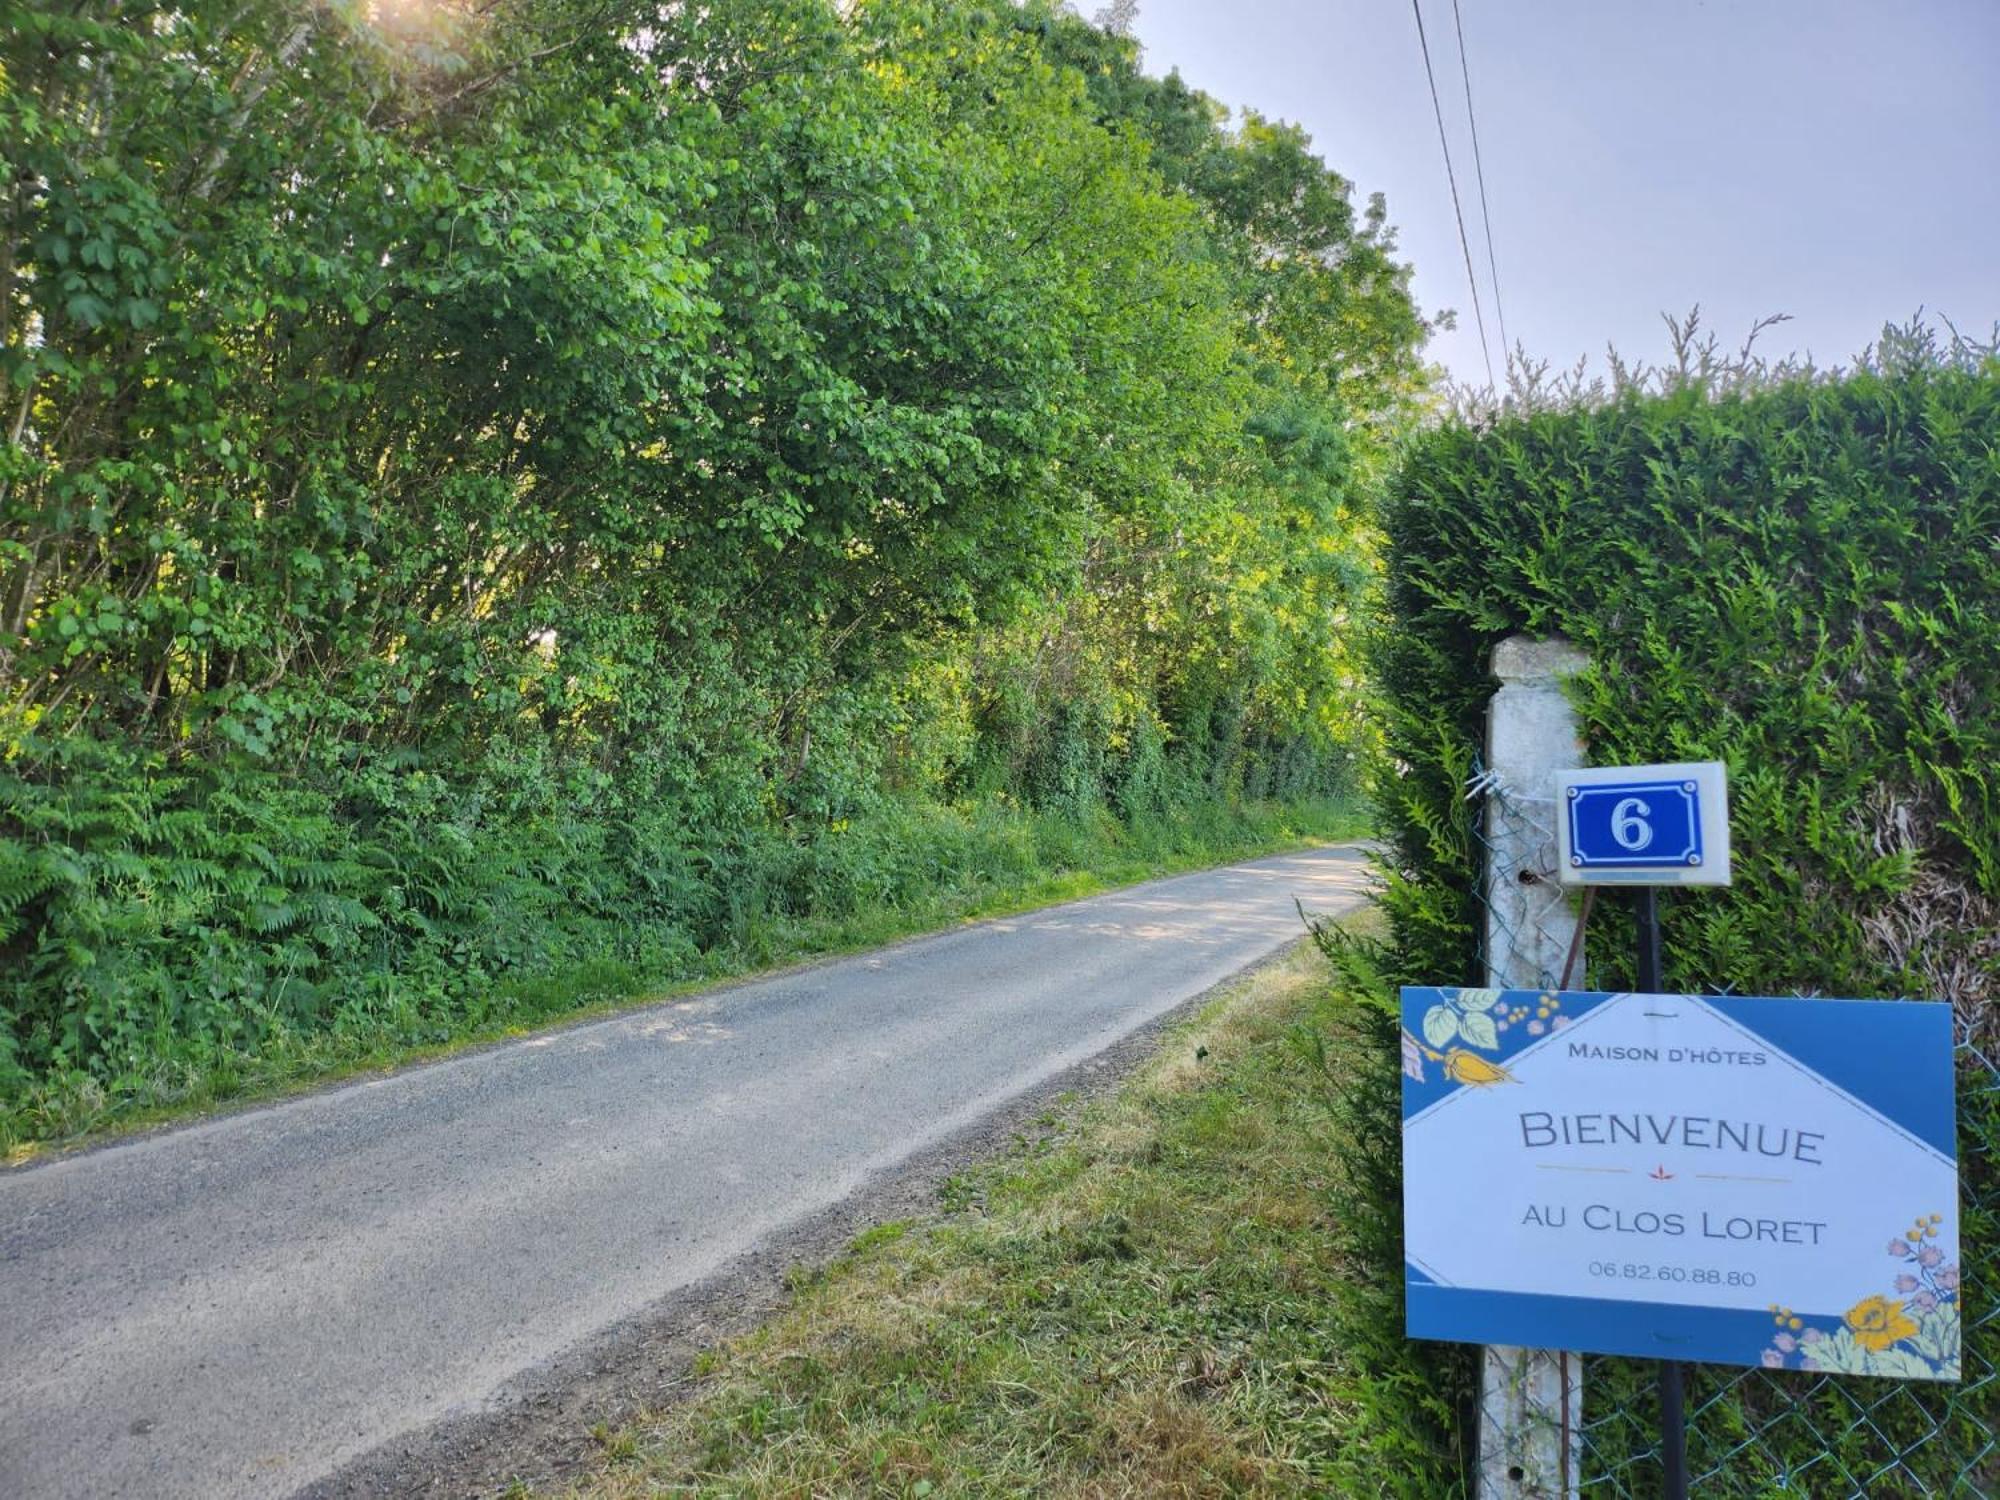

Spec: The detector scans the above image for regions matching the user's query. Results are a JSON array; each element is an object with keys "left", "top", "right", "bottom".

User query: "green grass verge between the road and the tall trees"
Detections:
[{"left": 0, "top": 802, "right": 1366, "bottom": 1164}]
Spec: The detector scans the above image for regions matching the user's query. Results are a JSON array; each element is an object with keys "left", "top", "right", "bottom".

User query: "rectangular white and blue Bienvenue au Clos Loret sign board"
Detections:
[{"left": 1402, "top": 992, "right": 1962, "bottom": 1380}]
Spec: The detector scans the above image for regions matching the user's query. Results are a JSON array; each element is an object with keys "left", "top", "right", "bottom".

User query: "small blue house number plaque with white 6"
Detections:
[{"left": 1556, "top": 760, "right": 1730, "bottom": 886}]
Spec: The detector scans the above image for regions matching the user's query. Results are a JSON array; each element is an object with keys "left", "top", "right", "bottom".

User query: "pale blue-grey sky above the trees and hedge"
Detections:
[{"left": 1128, "top": 0, "right": 2000, "bottom": 394}]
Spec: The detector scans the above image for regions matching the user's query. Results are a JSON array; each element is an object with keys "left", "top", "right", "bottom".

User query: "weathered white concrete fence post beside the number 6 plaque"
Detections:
[{"left": 1478, "top": 636, "right": 1586, "bottom": 1500}]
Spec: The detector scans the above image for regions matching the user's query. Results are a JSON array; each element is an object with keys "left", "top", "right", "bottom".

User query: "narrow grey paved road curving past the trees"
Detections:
[{"left": 0, "top": 850, "right": 1364, "bottom": 1500}]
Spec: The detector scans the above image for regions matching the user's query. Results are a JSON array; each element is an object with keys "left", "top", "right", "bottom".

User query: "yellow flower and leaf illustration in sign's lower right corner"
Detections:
[{"left": 1762, "top": 1214, "right": 1960, "bottom": 1380}]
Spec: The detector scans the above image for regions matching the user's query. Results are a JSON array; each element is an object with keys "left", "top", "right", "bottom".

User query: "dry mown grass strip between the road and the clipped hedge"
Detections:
[{"left": 548, "top": 924, "right": 1370, "bottom": 1500}]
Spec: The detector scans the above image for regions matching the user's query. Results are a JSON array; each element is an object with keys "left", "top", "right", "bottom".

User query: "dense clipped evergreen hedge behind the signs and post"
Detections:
[{"left": 1332, "top": 344, "right": 2000, "bottom": 1494}]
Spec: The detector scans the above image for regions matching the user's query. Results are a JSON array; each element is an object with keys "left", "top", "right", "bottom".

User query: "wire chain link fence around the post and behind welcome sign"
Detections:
[{"left": 1466, "top": 764, "right": 2000, "bottom": 1500}]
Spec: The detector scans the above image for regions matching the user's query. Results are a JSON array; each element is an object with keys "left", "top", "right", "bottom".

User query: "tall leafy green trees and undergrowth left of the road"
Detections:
[{"left": 0, "top": 0, "right": 1424, "bottom": 1128}]
